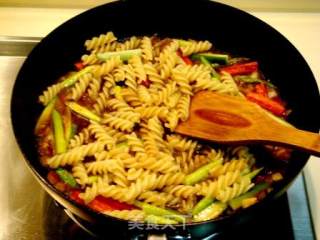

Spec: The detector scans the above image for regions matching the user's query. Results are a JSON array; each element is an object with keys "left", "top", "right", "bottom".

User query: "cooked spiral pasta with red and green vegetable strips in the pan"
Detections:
[{"left": 35, "top": 32, "right": 290, "bottom": 224}]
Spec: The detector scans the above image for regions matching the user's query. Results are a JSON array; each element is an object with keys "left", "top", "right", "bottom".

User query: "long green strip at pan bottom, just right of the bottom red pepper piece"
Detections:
[{"left": 134, "top": 201, "right": 185, "bottom": 223}]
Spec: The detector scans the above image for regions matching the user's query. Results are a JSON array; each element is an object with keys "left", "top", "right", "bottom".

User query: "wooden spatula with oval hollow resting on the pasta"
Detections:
[{"left": 175, "top": 91, "right": 320, "bottom": 156}]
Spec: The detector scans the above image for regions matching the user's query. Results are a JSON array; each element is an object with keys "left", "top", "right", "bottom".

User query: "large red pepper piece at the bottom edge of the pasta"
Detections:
[{"left": 89, "top": 196, "right": 135, "bottom": 212}]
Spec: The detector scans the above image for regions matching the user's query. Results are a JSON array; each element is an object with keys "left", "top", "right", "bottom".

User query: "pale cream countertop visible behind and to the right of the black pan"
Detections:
[{"left": 0, "top": 7, "right": 320, "bottom": 239}]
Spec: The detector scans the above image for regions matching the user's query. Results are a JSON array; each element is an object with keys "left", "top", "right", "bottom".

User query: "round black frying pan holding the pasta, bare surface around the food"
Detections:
[{"left": 11, "top": 0, "right": 320, "bottom": 239}]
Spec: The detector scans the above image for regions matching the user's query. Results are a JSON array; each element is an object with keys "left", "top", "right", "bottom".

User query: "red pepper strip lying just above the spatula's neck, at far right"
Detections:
[{"left": 246, "top": 92, "right": 286, "bottom": 116}]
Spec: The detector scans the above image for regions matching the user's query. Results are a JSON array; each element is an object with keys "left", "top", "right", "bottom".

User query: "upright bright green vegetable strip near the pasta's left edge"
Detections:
[{"left": 52, "top": 110, "right": 67, "bottom": 153}]
